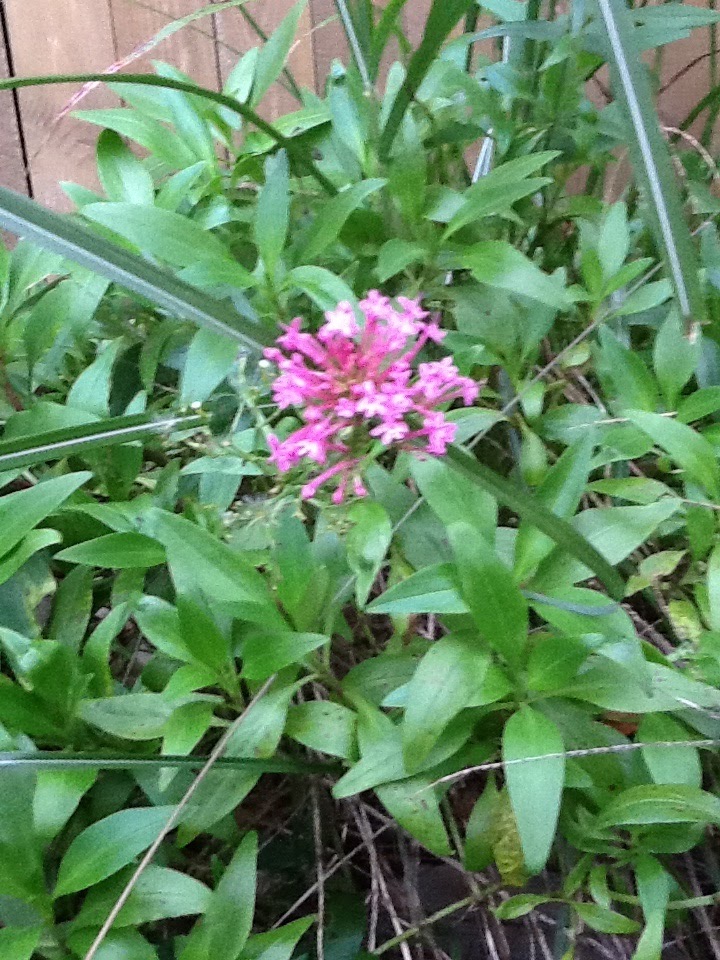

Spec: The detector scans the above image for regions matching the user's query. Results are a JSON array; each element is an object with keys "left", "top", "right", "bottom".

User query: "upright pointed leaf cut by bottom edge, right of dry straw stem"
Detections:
[{"left": 203, "top": 833, "right": 258, "bottom": 957}]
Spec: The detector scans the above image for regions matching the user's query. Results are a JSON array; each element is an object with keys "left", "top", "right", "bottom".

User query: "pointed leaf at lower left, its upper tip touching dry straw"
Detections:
[{"left": 54, "top": 806, "right": 175, "bottom": 898}]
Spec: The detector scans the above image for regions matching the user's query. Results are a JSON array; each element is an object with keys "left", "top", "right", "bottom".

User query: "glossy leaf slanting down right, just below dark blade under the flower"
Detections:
[{"left": 449, "top": 523, "right": 528, "bottom": 667}]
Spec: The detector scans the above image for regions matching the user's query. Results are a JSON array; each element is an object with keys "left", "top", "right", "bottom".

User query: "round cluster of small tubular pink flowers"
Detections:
[{"left": 265, "top": 291, "right": 479, "bottom": 503}]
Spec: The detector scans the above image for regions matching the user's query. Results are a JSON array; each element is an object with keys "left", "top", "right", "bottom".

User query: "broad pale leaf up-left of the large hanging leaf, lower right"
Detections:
[{"left": 402, "top": 635, "right": 489, "bottom": 773}]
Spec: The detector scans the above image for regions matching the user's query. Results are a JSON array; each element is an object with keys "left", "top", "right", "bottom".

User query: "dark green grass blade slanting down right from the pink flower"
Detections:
[{"left": 447, "top": 446, "right": 625, "bottom": 601}]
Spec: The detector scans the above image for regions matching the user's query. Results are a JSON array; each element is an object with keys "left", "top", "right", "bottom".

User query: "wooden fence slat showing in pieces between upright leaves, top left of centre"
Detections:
[{"left": 217, "top": 0, "right": 315, "bottom": 120}]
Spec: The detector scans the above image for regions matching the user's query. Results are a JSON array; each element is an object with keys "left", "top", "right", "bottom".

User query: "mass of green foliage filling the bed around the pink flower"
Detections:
[{"left": 0, "top": 0, "right": 720, "bottom": 960}]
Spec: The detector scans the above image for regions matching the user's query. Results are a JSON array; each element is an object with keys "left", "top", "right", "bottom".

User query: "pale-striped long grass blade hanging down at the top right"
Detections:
[{"left": 597, "top": 0, "right": 704, "bottom": 336}]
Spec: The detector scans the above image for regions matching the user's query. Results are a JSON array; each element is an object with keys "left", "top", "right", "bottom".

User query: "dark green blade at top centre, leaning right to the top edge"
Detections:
[{"left": 379, "top": 0, "right": 474, "bottom": 159}]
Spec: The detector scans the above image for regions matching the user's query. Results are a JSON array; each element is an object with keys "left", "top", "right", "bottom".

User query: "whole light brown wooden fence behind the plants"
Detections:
[{"left": 0, "top": 0, "right": 708, "bottom": 208}]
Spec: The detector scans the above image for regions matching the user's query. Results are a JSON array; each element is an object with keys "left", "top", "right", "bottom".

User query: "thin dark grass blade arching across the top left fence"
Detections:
[{"left": 0, "top": 72, "right": 334, "bottom": 195}]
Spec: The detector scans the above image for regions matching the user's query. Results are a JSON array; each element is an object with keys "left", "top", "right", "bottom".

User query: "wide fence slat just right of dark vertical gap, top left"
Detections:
[{"left": 5, "top": 0, "right": 115, "bottom": 210}]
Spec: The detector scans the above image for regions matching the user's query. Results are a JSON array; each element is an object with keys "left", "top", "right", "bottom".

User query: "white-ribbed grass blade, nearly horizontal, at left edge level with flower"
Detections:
[{"left": 0, "top": 413, "right": 206, "bottom": 473}]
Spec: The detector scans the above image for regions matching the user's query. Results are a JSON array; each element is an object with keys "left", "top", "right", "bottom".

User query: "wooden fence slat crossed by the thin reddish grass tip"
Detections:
[{"left": 110, "top": 0, "right": 219, "bottom": 90}]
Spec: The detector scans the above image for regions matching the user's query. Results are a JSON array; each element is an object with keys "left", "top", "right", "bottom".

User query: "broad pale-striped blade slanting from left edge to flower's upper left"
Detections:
[{"left": 0, "top": 187, "right": 262, "bottom": 353}]
